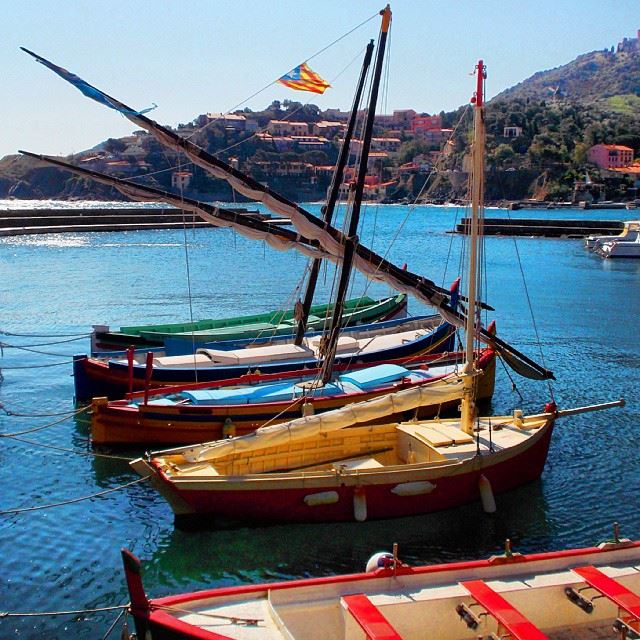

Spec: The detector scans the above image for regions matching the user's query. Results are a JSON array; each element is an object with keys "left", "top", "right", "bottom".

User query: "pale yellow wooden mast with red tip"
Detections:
[{"left": 461, "top": 60, "right": 486, "bottom": 434}]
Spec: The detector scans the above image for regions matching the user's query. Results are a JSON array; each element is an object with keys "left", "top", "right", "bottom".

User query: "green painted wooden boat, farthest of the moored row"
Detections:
[{"left": 92, "top": 294, "right": 407, "bottom": 350}]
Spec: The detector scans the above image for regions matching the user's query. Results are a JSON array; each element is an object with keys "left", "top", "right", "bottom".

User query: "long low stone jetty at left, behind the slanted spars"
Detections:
[{"left": 0, "top": 207, "right": 289, "bottom": 237}]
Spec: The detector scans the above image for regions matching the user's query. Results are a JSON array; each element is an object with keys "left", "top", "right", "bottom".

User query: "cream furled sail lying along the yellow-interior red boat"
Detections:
[{"left": 168, "top": 375, "right": 462, "bottom": 462}]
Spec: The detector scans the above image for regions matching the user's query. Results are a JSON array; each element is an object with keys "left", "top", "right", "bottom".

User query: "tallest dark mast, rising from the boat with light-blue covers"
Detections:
[{"left": 321, "top": 5, "right": 391, "bottom": 384}]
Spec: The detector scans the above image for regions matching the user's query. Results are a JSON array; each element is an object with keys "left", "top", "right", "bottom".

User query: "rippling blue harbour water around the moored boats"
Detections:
[{"left": 0, "top": 206, "right": 640, "bottom": 638}]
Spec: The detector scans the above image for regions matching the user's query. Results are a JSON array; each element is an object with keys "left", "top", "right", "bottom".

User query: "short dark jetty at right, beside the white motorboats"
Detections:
[{"left": 455, "top": 218, "right": 624, "bottom": 238}]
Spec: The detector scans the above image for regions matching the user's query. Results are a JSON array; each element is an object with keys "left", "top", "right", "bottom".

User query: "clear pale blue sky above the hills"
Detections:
[{"left": 0, "top": 0, "right": 640, "bottom": 157}]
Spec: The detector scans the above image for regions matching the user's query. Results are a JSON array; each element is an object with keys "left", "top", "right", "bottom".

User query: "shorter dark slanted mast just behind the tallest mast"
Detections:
[{"left": 294, "top": 40, "right": 373, "bottom": 345}]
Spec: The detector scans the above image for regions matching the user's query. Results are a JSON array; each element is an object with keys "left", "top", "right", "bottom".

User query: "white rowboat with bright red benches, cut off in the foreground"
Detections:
[{"left": 122, "top": 536, "right": 640, "bottom": 640}]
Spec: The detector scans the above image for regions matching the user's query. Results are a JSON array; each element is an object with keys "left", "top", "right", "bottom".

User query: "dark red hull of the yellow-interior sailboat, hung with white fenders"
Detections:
[{"left": 133, "top": 419, "right": 553, "bottom": 524}]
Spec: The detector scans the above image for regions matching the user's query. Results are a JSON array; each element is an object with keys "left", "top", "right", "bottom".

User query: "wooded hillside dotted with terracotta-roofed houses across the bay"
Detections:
[{"left": 0, "top": 32, "right": 640, "bottom": 201}]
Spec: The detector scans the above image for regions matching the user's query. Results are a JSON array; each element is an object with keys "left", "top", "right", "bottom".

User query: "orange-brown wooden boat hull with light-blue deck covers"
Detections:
[{"left": 91, "top": 347, "right": 495, "bottom": 446}]
